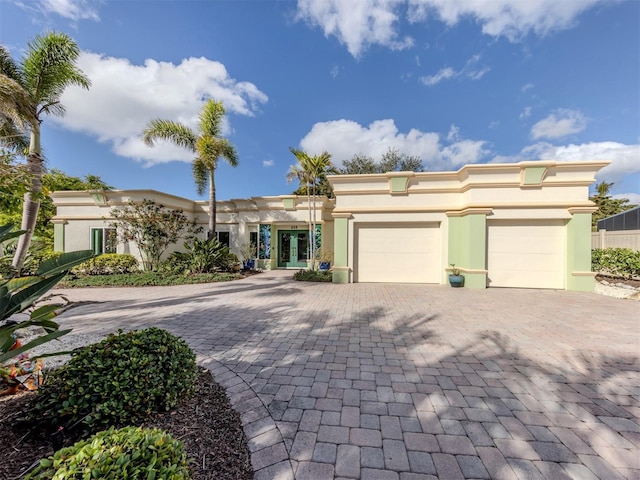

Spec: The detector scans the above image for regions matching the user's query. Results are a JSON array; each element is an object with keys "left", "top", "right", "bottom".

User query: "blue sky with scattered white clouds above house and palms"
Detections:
[{"left": 0, "top": 0, "right": 640, "bottom": 203}]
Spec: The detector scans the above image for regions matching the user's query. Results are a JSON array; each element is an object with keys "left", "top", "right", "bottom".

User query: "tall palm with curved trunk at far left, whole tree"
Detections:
[{"left": 0, "top": 32, "right": 91, "bottom": 271}]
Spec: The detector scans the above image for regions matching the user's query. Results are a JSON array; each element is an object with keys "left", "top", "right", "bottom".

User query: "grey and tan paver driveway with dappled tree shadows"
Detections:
[{"left": 56, "top": 271, "right": 640, "bottom": 480}]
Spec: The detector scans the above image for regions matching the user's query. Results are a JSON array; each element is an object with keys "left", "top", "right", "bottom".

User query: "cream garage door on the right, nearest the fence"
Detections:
[{"left": 487, "top": 220, "right": 566, "bottom": 289}]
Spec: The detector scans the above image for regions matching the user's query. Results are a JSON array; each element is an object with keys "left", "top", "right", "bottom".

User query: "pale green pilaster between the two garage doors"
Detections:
[{"left": 447, "top": 213, "right": 487, "bottom": 288}]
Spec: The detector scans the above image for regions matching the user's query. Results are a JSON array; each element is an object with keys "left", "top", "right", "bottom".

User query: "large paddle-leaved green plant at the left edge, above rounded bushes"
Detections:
[{"left": 0, "top": 225, "right": 93, "bottom": 375}]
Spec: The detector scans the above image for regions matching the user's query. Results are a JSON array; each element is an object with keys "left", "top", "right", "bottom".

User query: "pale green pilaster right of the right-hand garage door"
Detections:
[{"left": 566, "top": 213, "right": 595, "bottom": 292}]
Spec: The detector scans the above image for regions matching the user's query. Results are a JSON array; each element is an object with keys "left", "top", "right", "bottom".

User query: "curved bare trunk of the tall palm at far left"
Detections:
[{"left": 11, "top": 123, "right": 44, "bottom": 272}]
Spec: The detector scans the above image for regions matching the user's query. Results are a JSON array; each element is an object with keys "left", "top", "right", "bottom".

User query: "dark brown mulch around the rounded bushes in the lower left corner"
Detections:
[{"left": 0, "top": 369, "right": 253, "bottom": 480}]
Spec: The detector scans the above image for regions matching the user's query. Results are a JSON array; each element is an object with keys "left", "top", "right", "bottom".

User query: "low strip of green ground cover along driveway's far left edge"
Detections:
[{"left": 59, "top": 272, "right": 242, "bottom": 288}]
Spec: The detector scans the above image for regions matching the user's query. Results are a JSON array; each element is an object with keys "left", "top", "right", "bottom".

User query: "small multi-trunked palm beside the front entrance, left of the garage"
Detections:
[{"left": 287, "top": 148, "right": 338, "bottom": 268}]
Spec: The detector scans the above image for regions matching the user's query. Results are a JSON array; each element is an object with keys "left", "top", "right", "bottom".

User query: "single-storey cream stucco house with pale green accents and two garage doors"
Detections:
[{"left": 51, "top": 161, "right": 608, "bottom": 291}]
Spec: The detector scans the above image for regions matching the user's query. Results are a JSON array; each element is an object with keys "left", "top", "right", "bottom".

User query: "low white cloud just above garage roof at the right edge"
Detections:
[{"left": 510, "top": 142, "right": 640, "bottom": 182}]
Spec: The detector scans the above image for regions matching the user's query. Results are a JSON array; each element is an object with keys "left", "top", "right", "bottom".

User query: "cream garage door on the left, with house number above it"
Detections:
[{"left": 354, "top": 223, "right": 441, "bottom": 283}]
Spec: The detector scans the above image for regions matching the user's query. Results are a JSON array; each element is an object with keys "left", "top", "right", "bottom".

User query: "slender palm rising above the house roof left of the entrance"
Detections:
[{"left": 142, "top": 99, "right": 238, "bottom": 240}]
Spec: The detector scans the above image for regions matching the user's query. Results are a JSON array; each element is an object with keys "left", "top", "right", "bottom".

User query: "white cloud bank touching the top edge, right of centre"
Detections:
[{"left": 296, "top": 0, "right": 610, "bottom": 57}]
